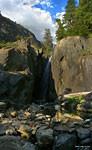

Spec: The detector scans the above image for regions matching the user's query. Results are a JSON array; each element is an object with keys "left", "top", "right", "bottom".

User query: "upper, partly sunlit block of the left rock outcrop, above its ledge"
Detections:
[{"left": 0, "top": 40, "right": 36, "bottom": 72}]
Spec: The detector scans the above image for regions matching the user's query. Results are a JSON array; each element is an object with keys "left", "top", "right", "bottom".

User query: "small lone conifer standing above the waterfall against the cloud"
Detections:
[{"left": 44, "top": 29, "right": 53, "bottom": 52}]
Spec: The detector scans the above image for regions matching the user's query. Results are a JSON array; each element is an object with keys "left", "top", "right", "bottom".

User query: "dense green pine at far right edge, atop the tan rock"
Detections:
[{"left": 74, "top": 0, "right": 92, "bottom": 37}]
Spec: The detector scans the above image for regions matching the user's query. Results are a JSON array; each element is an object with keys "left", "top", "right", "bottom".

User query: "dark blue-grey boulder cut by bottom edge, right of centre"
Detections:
[{"left": 53, "top": 133, "right": 77, "bottom": 150}]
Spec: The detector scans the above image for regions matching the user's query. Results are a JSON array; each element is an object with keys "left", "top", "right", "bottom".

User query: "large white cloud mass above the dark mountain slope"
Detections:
[{"left": 0, "top": 0, "right": 56, "bottom": 41}]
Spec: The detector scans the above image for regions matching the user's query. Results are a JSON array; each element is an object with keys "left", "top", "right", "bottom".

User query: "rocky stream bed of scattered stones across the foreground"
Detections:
[{"left": 0, "top": 94, "right": 92, "bottom": 150}]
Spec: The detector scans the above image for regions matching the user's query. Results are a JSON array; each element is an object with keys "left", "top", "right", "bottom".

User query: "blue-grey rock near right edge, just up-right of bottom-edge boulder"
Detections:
[{"left": 77, "top": 128, "right": 91, "bottom": 140}]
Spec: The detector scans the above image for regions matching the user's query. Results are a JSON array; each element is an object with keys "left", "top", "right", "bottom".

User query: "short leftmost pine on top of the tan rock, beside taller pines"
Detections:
[{"left": 56, "top": 18, "right": 65, "bottom": 41}]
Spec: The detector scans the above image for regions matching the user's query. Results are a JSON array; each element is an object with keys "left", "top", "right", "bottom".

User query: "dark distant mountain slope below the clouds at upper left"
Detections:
[{"left": 0, "top": 14, "right": 41, "bottom": 46}]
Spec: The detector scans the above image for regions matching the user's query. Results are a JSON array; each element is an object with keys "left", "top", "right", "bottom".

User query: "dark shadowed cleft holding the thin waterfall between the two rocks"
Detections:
[{"left": 33, "top": 53, "right": 57, "bottom": 102}]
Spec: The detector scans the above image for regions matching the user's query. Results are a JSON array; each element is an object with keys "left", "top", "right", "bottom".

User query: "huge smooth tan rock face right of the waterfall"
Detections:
[{"left": 51, "top": 36, "right": 92, "bottom": 95}]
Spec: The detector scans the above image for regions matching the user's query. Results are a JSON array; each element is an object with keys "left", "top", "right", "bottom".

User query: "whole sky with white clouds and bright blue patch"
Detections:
[{"left": 0, "top": 0, "right": 78, "bottom": 41}]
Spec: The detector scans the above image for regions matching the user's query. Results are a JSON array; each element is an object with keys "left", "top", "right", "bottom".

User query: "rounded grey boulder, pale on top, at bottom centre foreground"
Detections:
[{"left": 36, "top": 126, "right": 54, "bottom": 148}]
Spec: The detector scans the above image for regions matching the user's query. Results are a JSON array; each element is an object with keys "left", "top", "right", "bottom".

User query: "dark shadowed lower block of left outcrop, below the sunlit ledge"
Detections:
[{"left": 0, "top": 71, "right": 34, "bottom": 108}]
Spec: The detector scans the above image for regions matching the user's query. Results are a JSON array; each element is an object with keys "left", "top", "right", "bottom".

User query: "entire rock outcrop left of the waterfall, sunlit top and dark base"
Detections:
[{"left": 0, "top": 40, "right": 40, "bottom": 108}]
